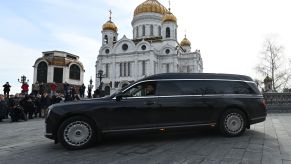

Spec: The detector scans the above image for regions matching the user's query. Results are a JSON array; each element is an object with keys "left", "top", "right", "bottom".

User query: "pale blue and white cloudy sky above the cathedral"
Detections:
[{"left": 0, "top": 0, "right": 291, "bottom": 93}]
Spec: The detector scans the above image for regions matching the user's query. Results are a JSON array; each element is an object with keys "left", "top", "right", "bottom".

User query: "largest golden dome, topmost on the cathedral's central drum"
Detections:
[{"left": 134, "top": 0, "right": 168, "bottom": 16}]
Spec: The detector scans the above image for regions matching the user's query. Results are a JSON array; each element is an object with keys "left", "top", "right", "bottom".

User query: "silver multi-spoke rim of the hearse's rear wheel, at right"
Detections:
[{"left": 224, "top": 113, "right": 244, "bottom": 134}]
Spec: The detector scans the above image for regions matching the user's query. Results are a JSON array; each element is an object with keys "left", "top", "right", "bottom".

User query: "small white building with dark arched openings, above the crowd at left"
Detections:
[{"left": 33, "top": 51, "right": 85, "bottom": 89}]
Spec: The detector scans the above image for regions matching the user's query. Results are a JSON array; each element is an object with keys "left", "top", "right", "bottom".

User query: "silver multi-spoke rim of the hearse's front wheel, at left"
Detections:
[{"left": 64, "top": 121, "right": 92, "bottom": 146}]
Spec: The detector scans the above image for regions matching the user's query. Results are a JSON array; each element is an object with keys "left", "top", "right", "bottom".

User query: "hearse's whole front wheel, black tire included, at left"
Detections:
[{"left": 57, "top": 116, "right": 97, "bottom": 150}]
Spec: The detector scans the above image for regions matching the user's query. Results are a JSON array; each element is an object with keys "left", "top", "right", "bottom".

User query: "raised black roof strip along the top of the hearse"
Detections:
[{"left": 142, "top": 73, "right": 253, "bottom": 81}]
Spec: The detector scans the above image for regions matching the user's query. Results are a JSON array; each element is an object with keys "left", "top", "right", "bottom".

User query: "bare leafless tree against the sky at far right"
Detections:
[{"left": 256, "top": 39, "right": 291, "bottom": 92}]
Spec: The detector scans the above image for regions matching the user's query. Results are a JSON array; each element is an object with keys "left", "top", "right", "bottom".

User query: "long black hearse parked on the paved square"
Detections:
[{"left": 45, "top": 73, "right": 266, "bottom": 149}]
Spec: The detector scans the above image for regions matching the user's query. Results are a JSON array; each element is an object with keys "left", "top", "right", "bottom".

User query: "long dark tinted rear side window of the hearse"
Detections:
[{"left": 157, "top": 80, "right": 255, "bottom": 96}]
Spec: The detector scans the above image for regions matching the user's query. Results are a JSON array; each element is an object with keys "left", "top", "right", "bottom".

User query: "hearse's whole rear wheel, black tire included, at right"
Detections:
[{"left": 219, "top": 109, "right": 247, "bottom": 137}]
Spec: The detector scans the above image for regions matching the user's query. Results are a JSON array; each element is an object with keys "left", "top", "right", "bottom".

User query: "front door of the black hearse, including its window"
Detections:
[{"left": 107, "top": 82, "right": 159, "bottom": 130}]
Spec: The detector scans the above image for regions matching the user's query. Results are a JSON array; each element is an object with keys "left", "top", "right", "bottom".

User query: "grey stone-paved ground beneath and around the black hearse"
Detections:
[{"left": 0, "top": 113, "right": 291, "bottom": 164}]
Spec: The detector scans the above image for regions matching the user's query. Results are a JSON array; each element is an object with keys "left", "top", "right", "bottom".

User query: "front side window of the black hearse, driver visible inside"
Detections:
[{"left": 123, "top": 82, "right": 156, "bottom": 97}]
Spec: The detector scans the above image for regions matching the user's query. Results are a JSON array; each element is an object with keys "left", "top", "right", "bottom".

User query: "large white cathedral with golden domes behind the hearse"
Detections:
[{"left": 95, "top": 0, "right": 203, "bottom": 94}]
